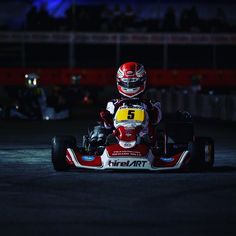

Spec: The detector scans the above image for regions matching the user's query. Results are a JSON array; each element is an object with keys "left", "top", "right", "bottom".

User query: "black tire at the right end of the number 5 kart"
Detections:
[{"left": 196, "top": 137, "right": 215, "bottom": 170}]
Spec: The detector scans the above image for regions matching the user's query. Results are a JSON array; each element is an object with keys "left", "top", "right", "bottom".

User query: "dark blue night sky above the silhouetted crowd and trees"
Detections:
[{"left": 0, "top": 0, "right": 236, "bottom": 28}]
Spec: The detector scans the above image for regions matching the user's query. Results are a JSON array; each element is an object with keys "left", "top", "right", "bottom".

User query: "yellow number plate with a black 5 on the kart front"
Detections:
[{"left": 116, "top": 108, "right": 145, "bottom": 122}]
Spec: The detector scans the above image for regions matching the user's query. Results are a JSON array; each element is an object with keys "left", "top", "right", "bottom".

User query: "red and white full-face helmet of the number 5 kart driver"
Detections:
[{"left": 116, "top": 62, "right": 147, "bottom": 98}]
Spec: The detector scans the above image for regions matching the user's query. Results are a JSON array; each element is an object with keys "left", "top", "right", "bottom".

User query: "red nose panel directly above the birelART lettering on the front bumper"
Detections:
[{"left": 106, "top": 144, "right": 149, "bottom": 157}]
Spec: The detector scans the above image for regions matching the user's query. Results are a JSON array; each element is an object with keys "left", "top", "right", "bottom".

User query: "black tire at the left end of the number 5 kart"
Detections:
[{"left": 51, "top": 136, "right": 76, "bottom": 171}]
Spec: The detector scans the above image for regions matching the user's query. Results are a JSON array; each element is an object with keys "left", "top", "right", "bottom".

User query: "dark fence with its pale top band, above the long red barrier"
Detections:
[{"left": 0, "top": 31, "right": 236, "bottom": 69}]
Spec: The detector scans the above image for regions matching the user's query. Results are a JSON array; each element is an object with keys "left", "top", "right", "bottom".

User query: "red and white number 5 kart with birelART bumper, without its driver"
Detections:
[{"left": 51, "top": 105, "right": 214, "bottom": 171}]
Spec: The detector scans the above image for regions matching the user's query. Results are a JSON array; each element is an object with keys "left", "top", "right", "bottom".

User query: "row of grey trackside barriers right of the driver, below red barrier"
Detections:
[{"left": 152, "top": 89, "right": 236, "bottom": 121}]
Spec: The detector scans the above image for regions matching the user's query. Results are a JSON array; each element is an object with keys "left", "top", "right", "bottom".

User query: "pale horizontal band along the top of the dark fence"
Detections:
[{"left": 0, "top": 31, "right": 236, "bottom": 45}]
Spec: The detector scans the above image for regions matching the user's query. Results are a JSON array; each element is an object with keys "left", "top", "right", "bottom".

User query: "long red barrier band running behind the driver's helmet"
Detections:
[{"left": 0, "top": 68, "right": 236, "bottom": 87}]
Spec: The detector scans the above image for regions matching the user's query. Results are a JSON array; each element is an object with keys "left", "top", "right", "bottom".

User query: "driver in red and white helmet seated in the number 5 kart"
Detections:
[{"left": 89, "top": 62, "right": 162, "bottom": 147}]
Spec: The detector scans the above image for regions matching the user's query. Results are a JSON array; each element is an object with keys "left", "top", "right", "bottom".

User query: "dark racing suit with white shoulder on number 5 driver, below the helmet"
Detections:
[{"left": 90, "top": 98, "right": 162, "bottom": 145}]
